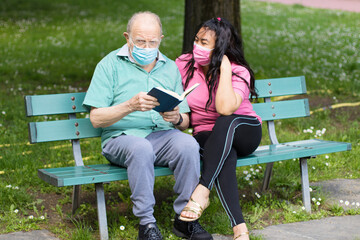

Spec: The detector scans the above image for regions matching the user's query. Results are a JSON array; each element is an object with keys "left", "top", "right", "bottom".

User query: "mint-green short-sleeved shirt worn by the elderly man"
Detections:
[{"left": 83, "top": 44, "right": 190, "bottom": 147}]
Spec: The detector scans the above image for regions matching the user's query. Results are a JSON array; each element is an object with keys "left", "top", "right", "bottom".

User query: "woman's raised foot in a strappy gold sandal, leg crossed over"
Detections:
[{"left": 179, "top": 184, "right": 210, "bottom": 222}]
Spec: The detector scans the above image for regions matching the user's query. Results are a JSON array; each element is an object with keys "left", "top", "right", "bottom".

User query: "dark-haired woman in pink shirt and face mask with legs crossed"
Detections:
[{"left": 176, "top": 18, "right": 262, "bottom": 240}]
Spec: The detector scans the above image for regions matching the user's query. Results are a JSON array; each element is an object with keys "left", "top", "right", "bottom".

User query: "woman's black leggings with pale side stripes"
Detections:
[{"left": 194, "top": 114, "right": 262, "bottom": 227}]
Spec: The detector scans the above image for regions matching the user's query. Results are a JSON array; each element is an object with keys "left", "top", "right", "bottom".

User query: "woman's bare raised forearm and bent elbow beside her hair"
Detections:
[{"left": 215, "top": 55, "right": 242, "bottom": 115}]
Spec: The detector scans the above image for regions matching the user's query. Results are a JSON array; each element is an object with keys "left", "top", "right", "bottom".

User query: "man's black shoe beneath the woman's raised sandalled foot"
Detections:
[{"left": 173, "top": 214, "right": 213, "bottom": 240}]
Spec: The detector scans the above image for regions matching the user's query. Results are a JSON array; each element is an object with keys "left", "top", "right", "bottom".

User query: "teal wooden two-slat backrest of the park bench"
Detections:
[{"left": 25, "top": 76, "right": 310, "bottom": 143}]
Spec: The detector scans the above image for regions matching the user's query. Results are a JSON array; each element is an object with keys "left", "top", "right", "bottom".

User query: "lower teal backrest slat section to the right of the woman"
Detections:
[{"left": 253, "top": 99, "right": 310, "bottom": 121}]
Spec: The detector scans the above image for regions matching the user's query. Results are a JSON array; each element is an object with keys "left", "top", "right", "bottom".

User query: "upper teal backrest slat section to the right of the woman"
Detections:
[{"left": 255, "top": 76, "right": 306, "bottom": 98}]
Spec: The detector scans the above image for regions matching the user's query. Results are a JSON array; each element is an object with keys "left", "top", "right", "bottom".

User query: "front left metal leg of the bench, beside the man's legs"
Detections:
[{"left": 95, "top": 183, "right": 109, "bottom": 240}]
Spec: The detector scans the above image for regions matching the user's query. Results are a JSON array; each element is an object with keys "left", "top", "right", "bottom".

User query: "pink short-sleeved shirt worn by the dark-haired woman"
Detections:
[{"left": 175, "top": 54, "right": 262, "bottom": 134}]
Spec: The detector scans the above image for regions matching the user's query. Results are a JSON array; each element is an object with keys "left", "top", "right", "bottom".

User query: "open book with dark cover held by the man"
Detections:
[{"left": 148, "top": 83, "right": 200, "bottom": 112}]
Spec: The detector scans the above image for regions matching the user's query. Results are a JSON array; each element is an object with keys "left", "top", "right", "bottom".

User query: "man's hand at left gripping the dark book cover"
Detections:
[{"left": 128, "top": 92, "right": 160, "bottom": 112}]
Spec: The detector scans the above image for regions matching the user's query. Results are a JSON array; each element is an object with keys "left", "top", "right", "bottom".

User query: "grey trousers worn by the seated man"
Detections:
[{"left": 102, "top": 129, "right": 200, "bottom": 225}]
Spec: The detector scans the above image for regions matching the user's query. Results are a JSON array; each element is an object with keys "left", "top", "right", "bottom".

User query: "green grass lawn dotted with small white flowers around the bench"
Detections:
[{"left": 0, "top": 0, "right": 360, "bottom": 239}]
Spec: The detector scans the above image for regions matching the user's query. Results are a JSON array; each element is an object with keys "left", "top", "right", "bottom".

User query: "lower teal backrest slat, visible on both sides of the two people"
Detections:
[{"left": 29, "top": 99, "right": 310, "bottom": 143}]
